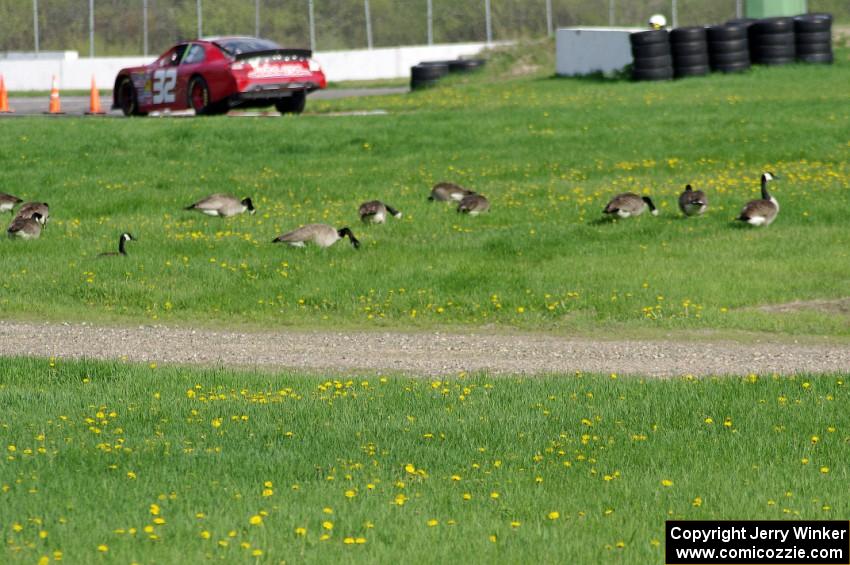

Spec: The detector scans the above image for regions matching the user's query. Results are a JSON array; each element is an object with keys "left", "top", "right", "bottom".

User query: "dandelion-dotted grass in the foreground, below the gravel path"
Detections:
[{"left": 0, "top": 359, "right": 850, "bottom": 563}]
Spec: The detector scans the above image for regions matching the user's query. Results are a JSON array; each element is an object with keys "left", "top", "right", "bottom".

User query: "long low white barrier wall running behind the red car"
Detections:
[{"left": 0, "top": 43, "right": 487, "bottom": 91}]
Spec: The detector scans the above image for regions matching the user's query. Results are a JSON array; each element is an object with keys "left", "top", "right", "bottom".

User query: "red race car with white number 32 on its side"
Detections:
[{"left": 112, "top": 37, "right": 327, "bottom": 116}]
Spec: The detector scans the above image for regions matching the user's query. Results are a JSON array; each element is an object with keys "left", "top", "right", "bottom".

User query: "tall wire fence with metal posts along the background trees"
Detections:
[{"left": 0, "top": 0, "right": 850, "bottom": 56}]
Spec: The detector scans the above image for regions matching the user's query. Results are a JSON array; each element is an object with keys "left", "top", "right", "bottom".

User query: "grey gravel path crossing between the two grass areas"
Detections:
[{"left": 0, "top": 321, "right": 850, "bottom": 377}]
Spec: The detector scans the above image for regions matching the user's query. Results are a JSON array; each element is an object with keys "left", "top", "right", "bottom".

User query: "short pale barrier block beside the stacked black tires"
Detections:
[{"left": 555, "top": 27, "right": 646, "bottom": 76}]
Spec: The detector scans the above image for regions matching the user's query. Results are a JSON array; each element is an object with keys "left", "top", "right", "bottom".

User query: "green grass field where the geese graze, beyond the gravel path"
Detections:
[{"left": 0, "top": 49, "right": 850, "bottom": 336}]
